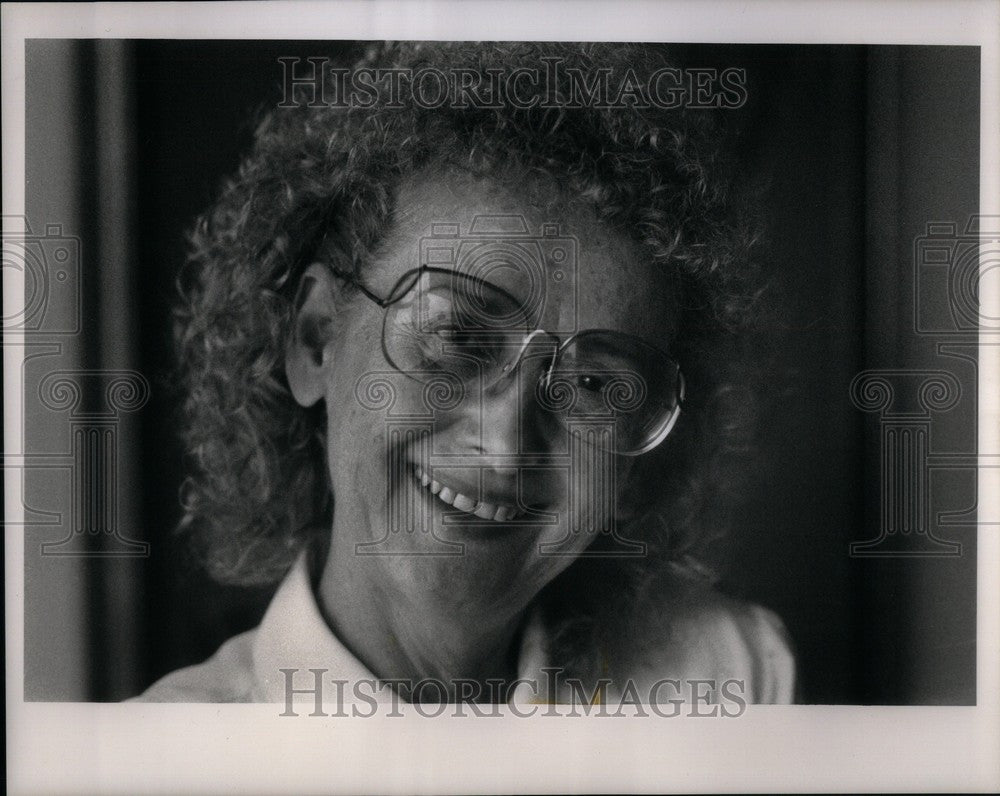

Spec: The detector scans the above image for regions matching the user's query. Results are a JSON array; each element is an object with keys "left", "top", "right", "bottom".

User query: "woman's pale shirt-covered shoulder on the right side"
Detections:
[{"left": 609, "top": 584, "right": 795, "bottom": 704}]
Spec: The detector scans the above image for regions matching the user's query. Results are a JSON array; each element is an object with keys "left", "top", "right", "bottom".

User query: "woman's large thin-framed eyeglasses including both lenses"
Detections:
[{"left": 333, "top": 265, "right": 684, "bottom": 456}]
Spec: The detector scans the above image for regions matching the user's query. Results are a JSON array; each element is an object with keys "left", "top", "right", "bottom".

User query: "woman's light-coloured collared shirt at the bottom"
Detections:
[{"left": 136, "top": 555, "right": 795, "bottom": 704}]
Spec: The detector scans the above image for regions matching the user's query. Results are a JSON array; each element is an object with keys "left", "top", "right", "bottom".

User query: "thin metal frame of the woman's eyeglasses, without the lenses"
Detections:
[{"left": 330, "top": 263, "right": 686, "bottom": 457}]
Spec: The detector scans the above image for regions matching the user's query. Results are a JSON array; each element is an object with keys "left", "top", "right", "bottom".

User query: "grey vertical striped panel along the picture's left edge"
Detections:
[{"left": 24, "top": 40, "right": 149, "bottom": 700}]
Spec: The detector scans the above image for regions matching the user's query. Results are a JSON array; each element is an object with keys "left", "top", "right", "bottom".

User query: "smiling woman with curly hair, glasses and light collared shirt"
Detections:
[{"left": 143, "top": 44, "right": 793, "bottom": 702}]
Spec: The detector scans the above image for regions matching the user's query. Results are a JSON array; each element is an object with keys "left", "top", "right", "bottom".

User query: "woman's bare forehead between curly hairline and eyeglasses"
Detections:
[{"left": 369, "top": 173, "right": 677, "bottom": 340}]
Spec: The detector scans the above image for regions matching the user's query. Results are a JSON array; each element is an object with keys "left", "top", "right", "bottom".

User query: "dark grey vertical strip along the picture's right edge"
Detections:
[{"left": 855, "top": 47, "right": 979, "bottom": 704}]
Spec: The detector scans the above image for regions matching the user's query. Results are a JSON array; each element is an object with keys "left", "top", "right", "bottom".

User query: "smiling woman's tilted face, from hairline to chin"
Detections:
[{"left": 312, "top": 169, "right": 677, "bottom": 615}]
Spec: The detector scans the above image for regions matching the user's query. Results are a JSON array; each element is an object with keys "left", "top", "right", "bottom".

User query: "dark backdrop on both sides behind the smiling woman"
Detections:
[{"left": 19, "top": 41, "right": 979, "bottom": 704}]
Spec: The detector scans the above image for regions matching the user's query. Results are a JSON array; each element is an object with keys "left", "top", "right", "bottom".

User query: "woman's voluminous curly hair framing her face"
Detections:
[{"left": 176, "top": 38, "right": 759, "bottom": 596}]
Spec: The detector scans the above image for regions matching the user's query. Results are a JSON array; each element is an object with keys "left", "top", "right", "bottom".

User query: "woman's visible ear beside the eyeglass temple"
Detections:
[{"left": 285, "top": 263, "right": 335, "bottom": 407}]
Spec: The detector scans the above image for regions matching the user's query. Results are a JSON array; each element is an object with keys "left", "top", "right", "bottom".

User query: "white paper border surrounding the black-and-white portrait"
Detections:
[{"left": 2, "top": 0, "right": 1000, "bottom": 793}]
